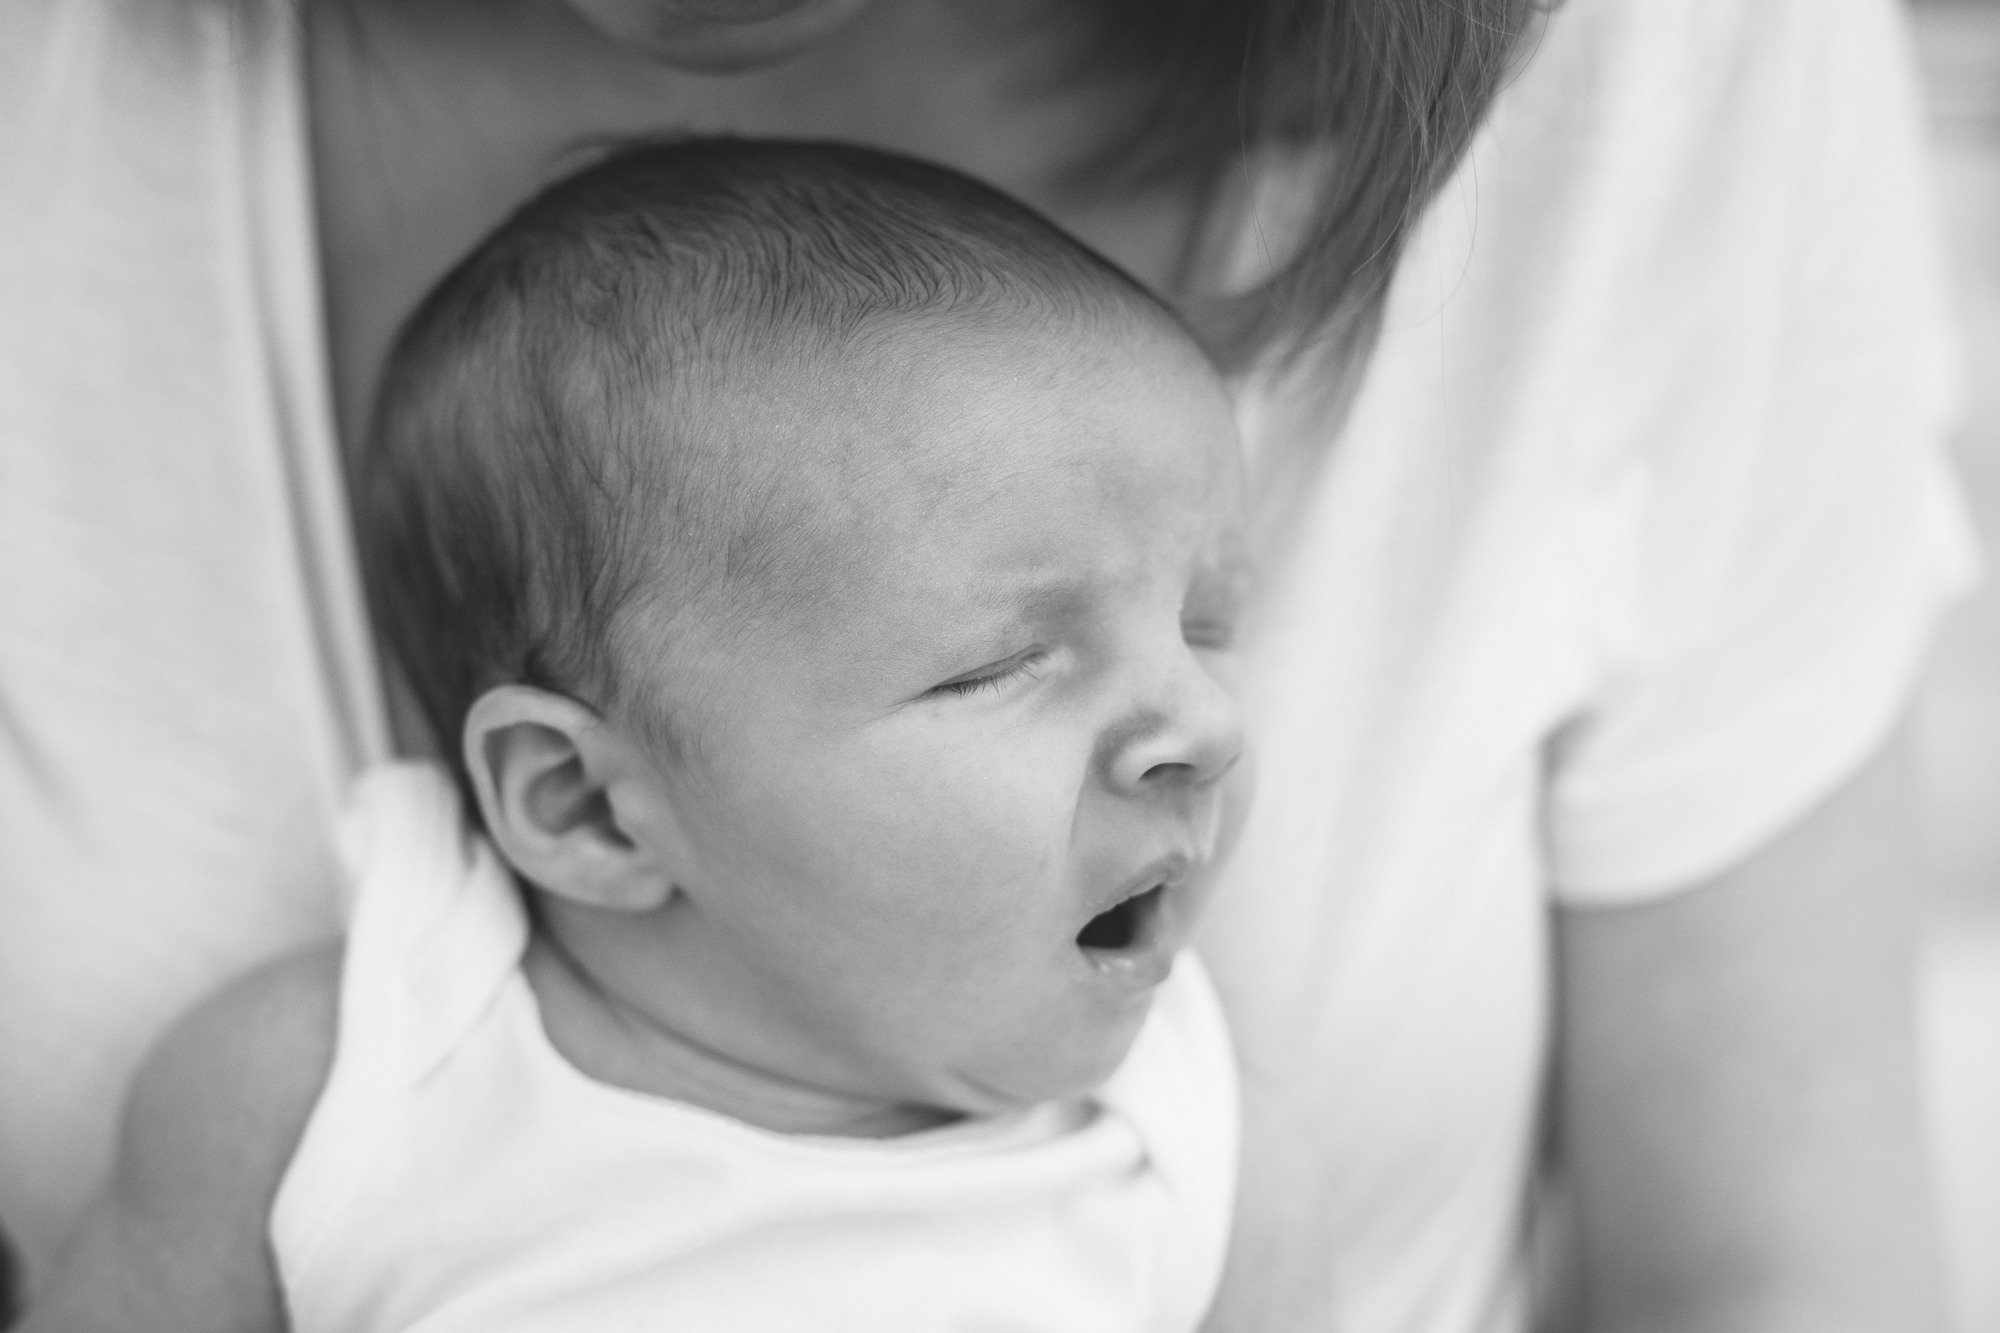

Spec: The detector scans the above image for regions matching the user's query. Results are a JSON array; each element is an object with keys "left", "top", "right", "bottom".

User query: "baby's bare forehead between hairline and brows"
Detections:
[{"left": 600, "top": 306, "right": 1238, "bottom": 728}]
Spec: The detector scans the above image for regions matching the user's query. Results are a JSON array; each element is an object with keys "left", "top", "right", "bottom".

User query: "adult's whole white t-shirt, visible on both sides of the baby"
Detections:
[{"left": 0, "top": 0, "right": 1968, "bottom": 1333}]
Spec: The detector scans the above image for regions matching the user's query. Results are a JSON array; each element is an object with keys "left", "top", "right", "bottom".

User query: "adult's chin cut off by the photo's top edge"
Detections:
[{"left": 564, "top": 0, "right": 872, "bottom": 74}]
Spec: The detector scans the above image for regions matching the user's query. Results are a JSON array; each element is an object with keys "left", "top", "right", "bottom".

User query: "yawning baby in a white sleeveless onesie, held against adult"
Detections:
[{"left": 30, "top": 140, "right": 1244, "bottom": 1333}]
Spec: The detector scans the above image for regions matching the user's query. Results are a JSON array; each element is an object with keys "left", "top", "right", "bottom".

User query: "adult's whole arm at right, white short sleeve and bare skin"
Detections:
[{"left": 1550, "top": 0, "right": 1970, "bottom": 1312}]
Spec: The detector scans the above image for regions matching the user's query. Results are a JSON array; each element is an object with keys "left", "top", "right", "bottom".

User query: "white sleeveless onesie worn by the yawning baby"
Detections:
[{"left": 270, "top": 763, "right": 1236, "bottom": 1333}]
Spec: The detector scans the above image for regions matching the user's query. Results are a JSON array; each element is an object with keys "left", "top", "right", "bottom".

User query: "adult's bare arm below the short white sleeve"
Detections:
[{"left": 1556, "top": 728, "right": 1942, "bottom": 1333}]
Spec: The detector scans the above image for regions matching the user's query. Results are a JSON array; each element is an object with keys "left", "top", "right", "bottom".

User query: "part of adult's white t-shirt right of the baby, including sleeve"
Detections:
[{"left": 1204, "top": 0, "right": 1974, "bottom": 1333}]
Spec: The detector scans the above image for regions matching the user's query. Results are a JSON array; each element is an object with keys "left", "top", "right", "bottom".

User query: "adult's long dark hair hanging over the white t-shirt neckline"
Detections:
[{"left": 1078, "top": 0, "right": 1554, "bottom": 364}]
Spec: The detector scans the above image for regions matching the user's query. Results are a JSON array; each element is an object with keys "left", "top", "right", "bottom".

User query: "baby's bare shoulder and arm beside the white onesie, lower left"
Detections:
[{"left": 22, "top": 947, "right": 340, "bottom": 1333}]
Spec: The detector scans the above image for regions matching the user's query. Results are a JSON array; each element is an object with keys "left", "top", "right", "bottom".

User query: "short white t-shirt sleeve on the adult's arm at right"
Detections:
[{"left": 1548, "top": 0, "right": 1976, "bottom": 905}]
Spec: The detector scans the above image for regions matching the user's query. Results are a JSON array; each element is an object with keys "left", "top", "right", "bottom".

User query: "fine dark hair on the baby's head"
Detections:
[{"left": 354, "top": 138, "right": 1174, "bottom": 783}]
